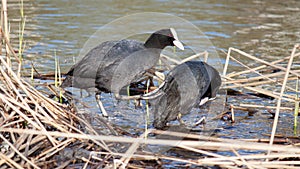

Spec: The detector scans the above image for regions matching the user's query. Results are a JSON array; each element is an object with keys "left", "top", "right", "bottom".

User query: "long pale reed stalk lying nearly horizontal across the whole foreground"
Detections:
[{"left": 0, "top": 128, "right": 300, "bottom": 153}]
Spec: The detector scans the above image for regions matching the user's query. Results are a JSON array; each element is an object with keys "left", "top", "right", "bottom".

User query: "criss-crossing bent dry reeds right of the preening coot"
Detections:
[{"left": 223, "top": 44, "right": 300, "bottom": 139}]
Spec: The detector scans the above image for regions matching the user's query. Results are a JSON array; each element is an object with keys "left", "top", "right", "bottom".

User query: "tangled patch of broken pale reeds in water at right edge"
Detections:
[{"left": 223, "top": 44, "right": 300, "bottom": 143}]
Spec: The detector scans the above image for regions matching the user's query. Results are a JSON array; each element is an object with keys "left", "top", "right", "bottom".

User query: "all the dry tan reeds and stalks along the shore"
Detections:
[{"left": 0, "top": 0, "right": 300, "bottom": 169}]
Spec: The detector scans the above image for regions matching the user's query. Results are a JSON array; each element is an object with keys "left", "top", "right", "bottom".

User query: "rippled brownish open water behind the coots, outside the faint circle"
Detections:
[{"left": 9, "top": 0, "right": 300, "bottom": 69}]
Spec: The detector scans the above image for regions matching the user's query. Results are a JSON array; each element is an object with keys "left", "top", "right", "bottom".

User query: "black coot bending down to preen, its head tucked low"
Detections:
[{"left": 153, "top": 61, "right": 221, "bottom": 129}]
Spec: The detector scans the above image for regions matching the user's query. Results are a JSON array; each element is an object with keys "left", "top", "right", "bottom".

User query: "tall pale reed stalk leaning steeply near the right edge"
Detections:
[{"left": 268, "top": 44, "right": 299, "bottom": 155}]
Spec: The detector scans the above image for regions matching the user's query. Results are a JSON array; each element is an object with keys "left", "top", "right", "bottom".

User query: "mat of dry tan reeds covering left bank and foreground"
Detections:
[{"left": 0, "top": 43, "right": 300, "bottom": 168}]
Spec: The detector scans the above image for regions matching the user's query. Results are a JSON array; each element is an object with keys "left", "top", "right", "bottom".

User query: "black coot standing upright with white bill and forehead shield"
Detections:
[{"left": 61, "top": 28, "right": 184, "bottom": 116}]
